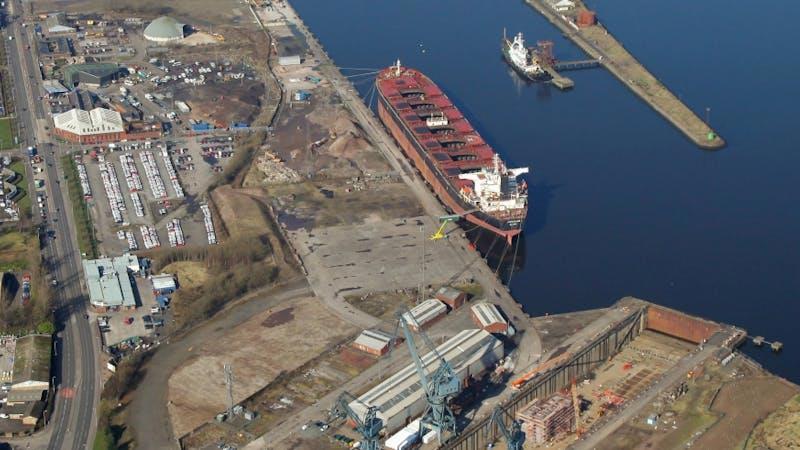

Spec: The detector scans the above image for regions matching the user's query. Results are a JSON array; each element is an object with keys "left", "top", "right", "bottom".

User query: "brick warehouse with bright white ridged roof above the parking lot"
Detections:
[{"left": 53, "top": 108, "right": 125, "bottom": 144}]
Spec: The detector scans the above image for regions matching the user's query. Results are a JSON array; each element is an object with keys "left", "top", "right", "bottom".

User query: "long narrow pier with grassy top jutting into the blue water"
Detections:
[{"left": 526, "top": 0, "right": 725, "bottom": 150}]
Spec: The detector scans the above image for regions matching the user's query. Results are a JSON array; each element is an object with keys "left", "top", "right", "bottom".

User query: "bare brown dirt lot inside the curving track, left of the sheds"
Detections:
[{"left": 167, "top": 297, "right": 355, "bottom": 436}]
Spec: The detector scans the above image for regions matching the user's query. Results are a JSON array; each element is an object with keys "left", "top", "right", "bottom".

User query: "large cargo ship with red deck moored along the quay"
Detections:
[{"left": 375, "top": 61, "right": 528, "bottom": 243}]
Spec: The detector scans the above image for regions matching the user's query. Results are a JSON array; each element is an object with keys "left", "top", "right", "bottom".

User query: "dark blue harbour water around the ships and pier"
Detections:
[{"left": 292, "top": 0, "right": 800, "bottom": 381}]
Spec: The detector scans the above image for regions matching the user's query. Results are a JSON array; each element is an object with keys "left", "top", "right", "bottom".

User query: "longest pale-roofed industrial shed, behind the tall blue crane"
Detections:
[{"left": 350, "top": 329, "right": 503, "bottom": 433}]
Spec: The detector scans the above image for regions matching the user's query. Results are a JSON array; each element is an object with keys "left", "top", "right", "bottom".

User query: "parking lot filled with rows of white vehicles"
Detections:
[{"left": 77, "top": 138, "right": 227, "bottom": 254}]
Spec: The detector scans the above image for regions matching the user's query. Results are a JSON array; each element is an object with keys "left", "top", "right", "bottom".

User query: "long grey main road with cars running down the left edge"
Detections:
[{"left": 6, "top": 2, "right": 100, "bottom": 450}]
